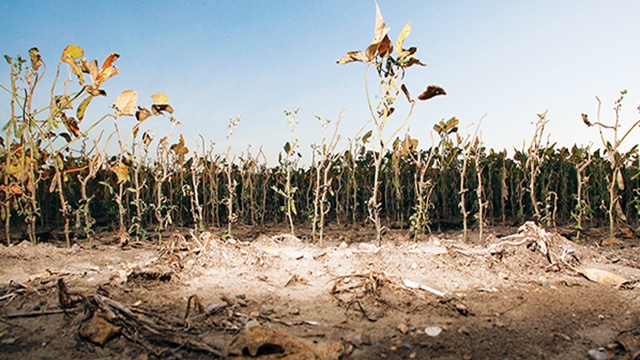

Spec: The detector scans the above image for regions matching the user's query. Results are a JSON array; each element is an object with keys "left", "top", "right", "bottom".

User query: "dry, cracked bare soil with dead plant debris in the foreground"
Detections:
[{"left": 0, "top": 225, "right": 640, "bottom": 360}]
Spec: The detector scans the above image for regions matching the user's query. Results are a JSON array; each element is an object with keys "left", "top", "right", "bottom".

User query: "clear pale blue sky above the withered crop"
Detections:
[{"left": 0, "top": 0, "right": 640, "bottom": 164}]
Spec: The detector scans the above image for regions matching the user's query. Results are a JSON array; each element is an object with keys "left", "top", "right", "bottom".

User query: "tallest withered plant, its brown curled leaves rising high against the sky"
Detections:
[{"left": 338, "top": 3, "right": 446, "bottom": 245}]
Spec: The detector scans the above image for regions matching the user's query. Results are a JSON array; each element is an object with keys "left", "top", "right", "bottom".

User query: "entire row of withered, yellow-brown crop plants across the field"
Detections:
[{"left": 0, "top": 6, "right": 640, "bottom": 246}]
